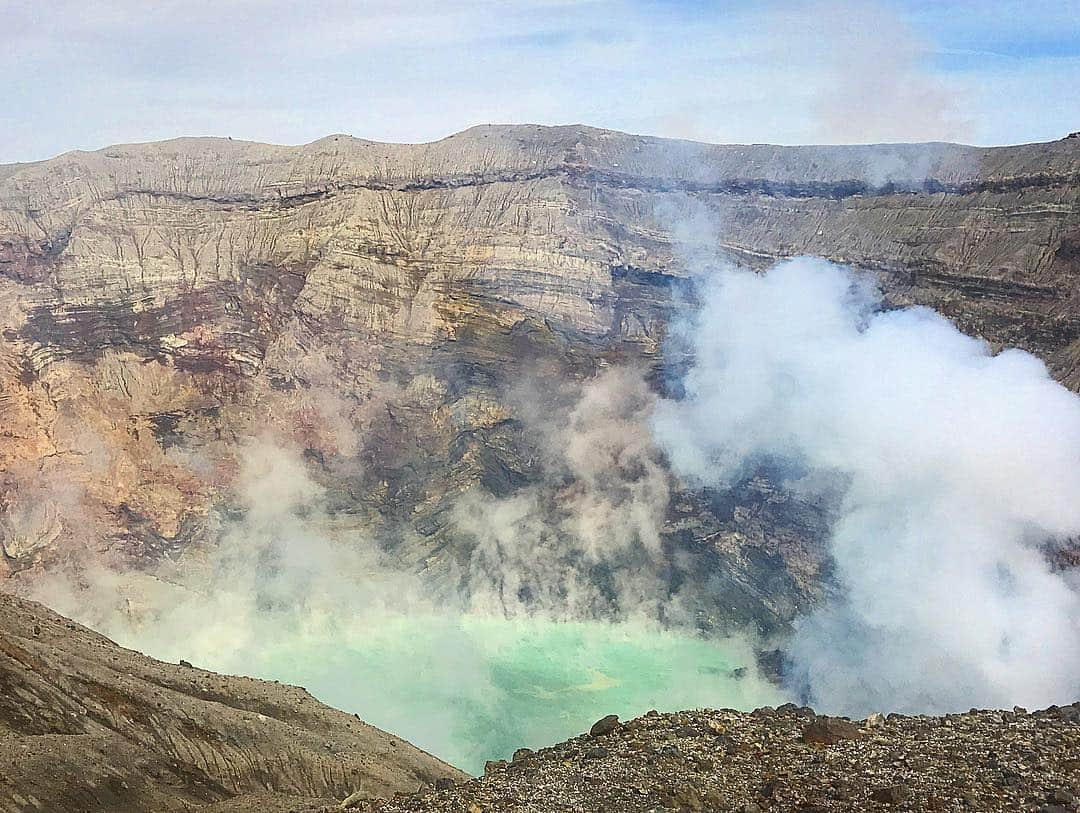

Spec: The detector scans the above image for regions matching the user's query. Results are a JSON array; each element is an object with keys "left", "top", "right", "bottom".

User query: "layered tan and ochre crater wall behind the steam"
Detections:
[{"left": 0, "top": 126, "right": 1080, "bottom": 629}]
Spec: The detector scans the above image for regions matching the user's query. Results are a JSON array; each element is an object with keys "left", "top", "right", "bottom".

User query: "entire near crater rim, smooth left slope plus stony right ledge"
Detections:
[{"left": 0, "top": 595, "right": 1080, "bottom": 813}]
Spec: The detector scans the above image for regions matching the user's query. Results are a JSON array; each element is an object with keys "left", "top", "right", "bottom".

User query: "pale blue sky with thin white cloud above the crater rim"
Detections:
[{"left": 0, "top": 0, "right": 1080, "bottom": 162}]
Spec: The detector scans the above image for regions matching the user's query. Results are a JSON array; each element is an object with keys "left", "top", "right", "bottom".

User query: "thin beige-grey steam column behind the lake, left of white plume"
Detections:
[{"left": 453, "top": 368, "right": 675, "bottom": 620}]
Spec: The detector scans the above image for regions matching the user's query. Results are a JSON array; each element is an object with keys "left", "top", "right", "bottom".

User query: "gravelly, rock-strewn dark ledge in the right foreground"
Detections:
[{"left": 349, "top": 704, "right": 1080, "bottom": 813}]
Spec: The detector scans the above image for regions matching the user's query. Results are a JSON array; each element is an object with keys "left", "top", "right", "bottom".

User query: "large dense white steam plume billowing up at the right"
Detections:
[{"left": 654, "top": 258, "right": 1080, "bottom": 714}]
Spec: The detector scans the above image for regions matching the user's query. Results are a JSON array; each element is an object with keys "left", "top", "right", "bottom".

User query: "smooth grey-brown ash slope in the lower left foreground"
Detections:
[{"left": 0, "top": 595, "right": 463, "bottom": 813}]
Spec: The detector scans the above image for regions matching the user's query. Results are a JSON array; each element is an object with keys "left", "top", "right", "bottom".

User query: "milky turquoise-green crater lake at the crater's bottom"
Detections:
[{"left": 234, "top": 615, "right": 780, "bottom": 773}]
